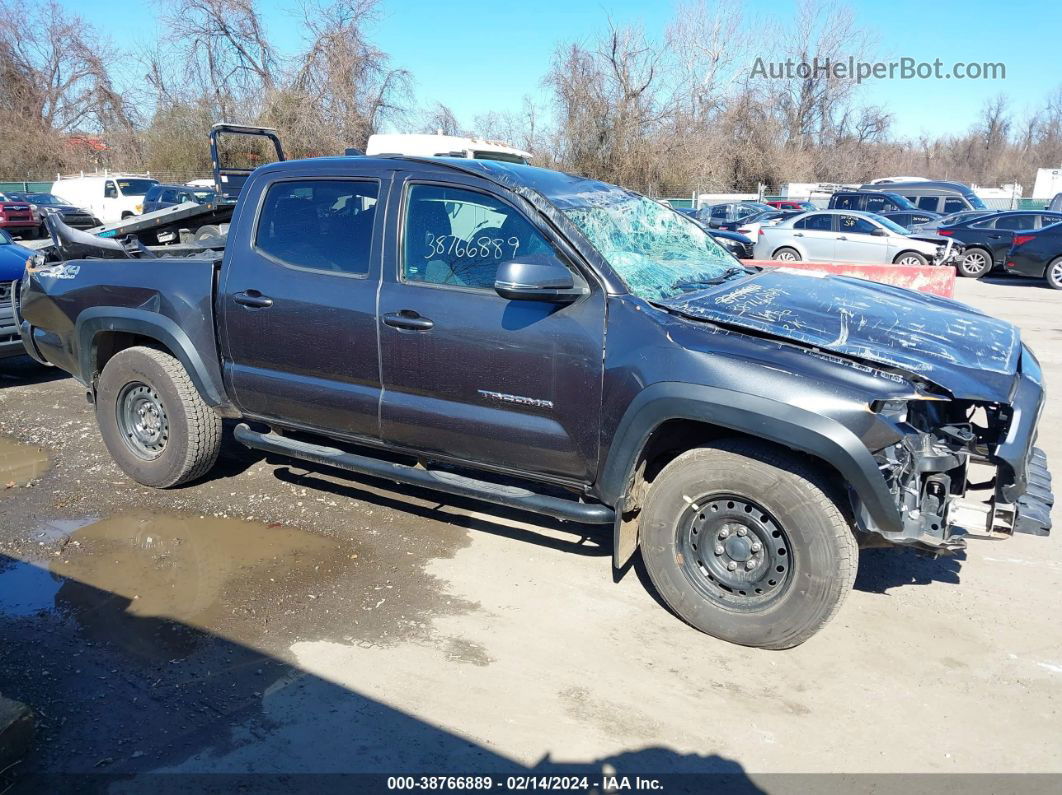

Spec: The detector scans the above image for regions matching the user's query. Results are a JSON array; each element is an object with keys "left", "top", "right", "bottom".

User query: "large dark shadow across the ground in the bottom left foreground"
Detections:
[{"left": 0, "top": 556, "right": 758, "bottom": 793}]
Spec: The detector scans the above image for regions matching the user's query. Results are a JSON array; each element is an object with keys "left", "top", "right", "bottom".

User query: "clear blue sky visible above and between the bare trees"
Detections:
[{"left": 70, "top": 0, "right": 1062, "bottom": 137}]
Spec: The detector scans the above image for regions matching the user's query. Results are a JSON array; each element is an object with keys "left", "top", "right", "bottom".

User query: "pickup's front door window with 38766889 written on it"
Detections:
[{"left": 401, "top": 185, "right": 552, "bottom": 291}]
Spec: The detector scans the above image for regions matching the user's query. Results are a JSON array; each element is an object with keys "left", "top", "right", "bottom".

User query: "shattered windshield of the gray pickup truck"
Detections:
[{"left": 550, "top": 183, "right": 751, "bottom": 300}]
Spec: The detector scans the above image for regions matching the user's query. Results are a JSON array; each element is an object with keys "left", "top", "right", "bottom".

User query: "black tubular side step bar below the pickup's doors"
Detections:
[{"left": 234, "top": 422, "right": 616, "bottom": 524}]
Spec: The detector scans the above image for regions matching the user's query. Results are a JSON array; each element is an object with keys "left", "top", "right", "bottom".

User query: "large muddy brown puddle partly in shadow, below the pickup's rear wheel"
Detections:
[{"left": 0, "top": 513, "right": 378, "bottom": 660}]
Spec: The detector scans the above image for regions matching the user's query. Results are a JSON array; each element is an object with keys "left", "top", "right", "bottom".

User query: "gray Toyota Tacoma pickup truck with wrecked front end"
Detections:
[{"left": 18, "top": 156, "right": 1054, "bottom": 649}]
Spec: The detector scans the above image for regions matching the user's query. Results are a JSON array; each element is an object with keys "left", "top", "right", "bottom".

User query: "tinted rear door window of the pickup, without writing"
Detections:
[{"left": 255, "top": 179, "right": 379, "bottom": 274}]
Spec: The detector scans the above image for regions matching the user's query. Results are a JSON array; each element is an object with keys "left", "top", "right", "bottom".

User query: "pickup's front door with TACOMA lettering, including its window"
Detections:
[{"left": 379, "top": 175, "right": 605, "bottom": 482}]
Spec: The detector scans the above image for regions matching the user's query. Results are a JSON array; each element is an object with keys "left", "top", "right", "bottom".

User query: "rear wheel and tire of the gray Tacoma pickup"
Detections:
[{"left": 96, "top": 347, "right": 221, "bottom": 488}]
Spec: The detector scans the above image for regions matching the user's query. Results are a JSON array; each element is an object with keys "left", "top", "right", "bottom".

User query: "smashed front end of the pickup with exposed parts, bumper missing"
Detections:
[{"left": 860, "top": 349, "right": 1055, "bottom": 553}]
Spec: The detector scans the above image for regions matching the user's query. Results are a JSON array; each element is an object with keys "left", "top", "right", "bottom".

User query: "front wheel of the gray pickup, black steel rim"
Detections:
[{"left": 640, "top": 439, "right": 858, "bottom": 649}]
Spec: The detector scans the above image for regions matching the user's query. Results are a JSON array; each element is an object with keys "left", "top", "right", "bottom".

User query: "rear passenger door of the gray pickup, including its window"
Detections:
[{"left": 222, "top": 176, "right": 388, "bottom": 439}]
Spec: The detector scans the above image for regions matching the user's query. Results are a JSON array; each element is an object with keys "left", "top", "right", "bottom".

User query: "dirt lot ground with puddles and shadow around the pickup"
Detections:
[{"left": 0, "top": 273, "right": 1062, "bottom": 790}]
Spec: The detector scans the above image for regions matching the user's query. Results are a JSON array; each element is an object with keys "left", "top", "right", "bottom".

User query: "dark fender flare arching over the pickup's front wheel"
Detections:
[{"left": 598, "top": 381, "right": 903, "bottom": 564}]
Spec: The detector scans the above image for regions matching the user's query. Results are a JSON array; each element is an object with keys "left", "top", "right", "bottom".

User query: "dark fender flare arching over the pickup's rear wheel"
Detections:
[{"left": 74, "top": 307, "right": 228, "bottom": 408}]
